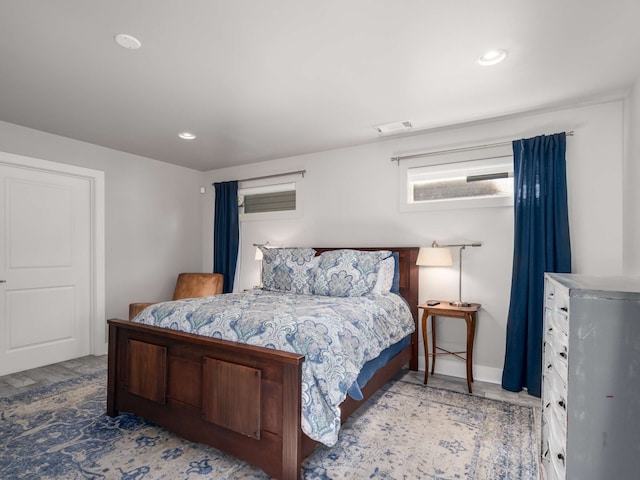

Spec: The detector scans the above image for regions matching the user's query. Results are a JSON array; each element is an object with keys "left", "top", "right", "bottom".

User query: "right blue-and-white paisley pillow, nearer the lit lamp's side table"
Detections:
[{"left": 313, "top": 250, "right": 391, "bottom": 297}]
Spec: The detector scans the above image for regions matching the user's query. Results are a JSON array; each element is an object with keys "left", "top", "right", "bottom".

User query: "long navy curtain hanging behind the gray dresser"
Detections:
[{"left": 502, "top": 133, "right": 571, "bottom": 397}]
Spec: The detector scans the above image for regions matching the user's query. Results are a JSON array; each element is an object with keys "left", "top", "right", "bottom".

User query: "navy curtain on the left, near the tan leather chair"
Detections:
[{"left": 213, "top": 181, "right": 240, "bottom": 293}]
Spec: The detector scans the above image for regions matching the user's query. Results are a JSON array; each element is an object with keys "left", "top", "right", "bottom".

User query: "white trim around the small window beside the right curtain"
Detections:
[{"left": 397, "top": 144, "right": 513, "bottom": 212}]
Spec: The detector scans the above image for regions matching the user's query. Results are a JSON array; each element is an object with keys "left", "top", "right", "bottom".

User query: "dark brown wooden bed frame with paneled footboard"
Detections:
[{"left": 107, "top": 247, "right": 418, "bottom": 480}]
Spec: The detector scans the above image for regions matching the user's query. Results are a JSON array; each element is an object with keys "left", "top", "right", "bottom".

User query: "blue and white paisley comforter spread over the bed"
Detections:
[{"left": 134, "top": 290, "right": 415, "bottom": 446}]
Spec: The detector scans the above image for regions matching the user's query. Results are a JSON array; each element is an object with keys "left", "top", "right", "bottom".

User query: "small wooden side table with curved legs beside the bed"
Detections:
[{"left": 418, "top": 301, "right": 480, "bottom": 393}]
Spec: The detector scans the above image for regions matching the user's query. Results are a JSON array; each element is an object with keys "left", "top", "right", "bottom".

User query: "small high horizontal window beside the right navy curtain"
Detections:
[{"left": 400, "top": 142, "right": 513, "bottom": 211}]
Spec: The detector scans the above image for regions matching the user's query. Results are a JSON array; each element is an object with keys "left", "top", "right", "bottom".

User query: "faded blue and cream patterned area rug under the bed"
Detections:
[{"left": 0, "top": 372, "right": 537, "bottom": 480}]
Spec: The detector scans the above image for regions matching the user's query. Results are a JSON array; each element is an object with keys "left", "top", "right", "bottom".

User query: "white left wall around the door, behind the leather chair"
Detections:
[{"left": 0, "top": 122, "right": 202, "bottom": 318}]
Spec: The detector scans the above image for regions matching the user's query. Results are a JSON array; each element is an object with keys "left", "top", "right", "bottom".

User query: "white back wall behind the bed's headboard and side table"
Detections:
[{"left": 203, "top": 100, "right": 623, "bottom": 382}]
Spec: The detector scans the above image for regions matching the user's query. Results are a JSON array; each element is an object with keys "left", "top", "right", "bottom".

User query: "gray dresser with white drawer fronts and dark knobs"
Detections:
[{"left": 541, "top": 273, "right": 640, "bottom": 480}]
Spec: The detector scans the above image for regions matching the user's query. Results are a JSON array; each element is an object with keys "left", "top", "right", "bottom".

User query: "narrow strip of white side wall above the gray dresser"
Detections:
[{"left": 624, "top": 77, "right": 640, "bottom": 275}]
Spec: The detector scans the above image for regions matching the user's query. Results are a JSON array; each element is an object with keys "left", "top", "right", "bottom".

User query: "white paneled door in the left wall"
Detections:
[{"left": 0, "top": 161, "right": 91, "bottom": 375}]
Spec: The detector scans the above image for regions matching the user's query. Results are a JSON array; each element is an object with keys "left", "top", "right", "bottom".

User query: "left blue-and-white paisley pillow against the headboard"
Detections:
[{"left": 260, "top": 247, "right": 316, "bottom": 295}]
